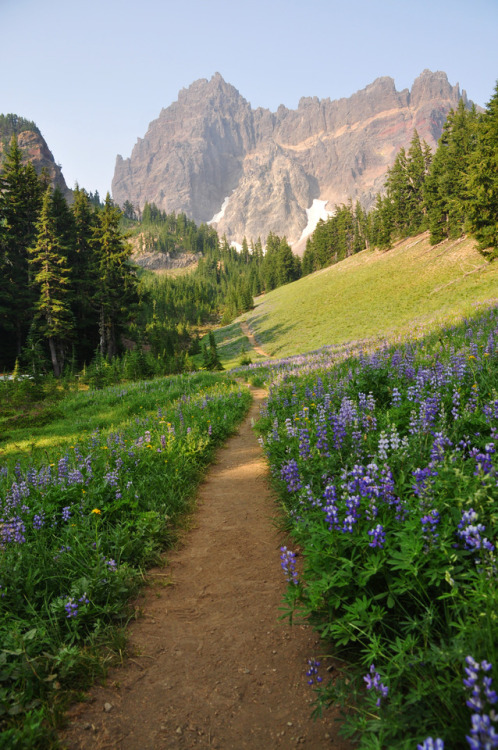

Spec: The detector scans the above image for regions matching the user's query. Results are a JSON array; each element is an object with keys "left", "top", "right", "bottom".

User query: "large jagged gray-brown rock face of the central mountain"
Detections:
[{"left": 112, "top": 70, "right": 467, "bottom": 242}]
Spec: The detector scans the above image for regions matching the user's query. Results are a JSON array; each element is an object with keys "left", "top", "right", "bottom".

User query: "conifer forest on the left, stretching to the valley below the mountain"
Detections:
[{"left": 0, "top": 133, "right": 301, "bottom": 379}]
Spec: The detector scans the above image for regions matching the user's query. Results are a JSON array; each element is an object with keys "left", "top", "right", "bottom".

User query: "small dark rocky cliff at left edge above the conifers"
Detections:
[{"left": 0, "top": 115, "right": 72, "bottom": 199}]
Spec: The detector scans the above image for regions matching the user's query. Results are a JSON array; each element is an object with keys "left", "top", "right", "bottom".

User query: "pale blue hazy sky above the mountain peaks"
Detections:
[{"left": 0, "top": 0, "right": 498, "bottom": 195}]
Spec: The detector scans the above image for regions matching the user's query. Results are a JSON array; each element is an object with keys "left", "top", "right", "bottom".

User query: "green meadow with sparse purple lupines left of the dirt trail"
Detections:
[{"left": 0, "top": 373, "right": 250, "bottom": 748}]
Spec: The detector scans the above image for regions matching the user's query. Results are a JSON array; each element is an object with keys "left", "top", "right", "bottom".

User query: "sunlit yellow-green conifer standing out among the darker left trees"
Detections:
[{"left": 29, "top": 189, "right": 73, "bottom": 377}]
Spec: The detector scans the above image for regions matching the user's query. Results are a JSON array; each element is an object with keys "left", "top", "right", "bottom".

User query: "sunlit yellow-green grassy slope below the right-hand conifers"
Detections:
[{"left": 226, "top": 233, "right": 498, "bottom": 361}]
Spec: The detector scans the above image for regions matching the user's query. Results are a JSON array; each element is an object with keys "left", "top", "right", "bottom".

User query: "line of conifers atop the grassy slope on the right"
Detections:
[{"left": 302, "top": 84, "right": 498, "bottom": 274}]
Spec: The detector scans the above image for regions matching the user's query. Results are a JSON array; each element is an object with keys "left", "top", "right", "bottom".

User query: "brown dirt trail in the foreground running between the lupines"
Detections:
[{"left": 61, "top": 390, "right": 348, "bottom": 750}]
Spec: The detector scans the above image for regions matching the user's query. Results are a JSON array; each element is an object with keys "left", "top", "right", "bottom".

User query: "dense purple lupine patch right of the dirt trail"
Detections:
[{"left": 255, "top": 307, "right": 498, "bottom": 750}]
